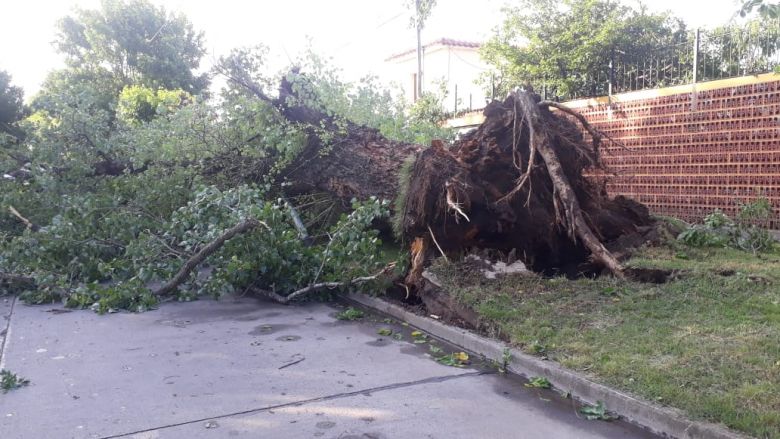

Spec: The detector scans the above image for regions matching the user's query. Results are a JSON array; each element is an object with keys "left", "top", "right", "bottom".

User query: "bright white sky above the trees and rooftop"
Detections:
[{"left": 0, "top": 0, "right": 737, "bottom": 98}]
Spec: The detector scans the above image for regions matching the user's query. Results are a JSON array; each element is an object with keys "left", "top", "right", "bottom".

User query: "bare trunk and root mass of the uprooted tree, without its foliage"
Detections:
[{"left": 230, "top": 72, "right": 653, "bottom": 296}]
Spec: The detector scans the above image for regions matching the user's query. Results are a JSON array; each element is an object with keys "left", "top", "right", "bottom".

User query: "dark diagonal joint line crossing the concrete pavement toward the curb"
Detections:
[{"left": 100, "top": 371, "right": 490, "bottom": 439}]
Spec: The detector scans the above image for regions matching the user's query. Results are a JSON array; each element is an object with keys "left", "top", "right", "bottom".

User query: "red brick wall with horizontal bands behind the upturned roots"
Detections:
[{"left": 569, "top": 75, "right": 780, "bottom": 229}]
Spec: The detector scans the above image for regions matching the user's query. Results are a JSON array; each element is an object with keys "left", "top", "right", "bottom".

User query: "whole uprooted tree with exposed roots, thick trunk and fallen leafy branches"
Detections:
[{"left": 0, "top": 65, "right": 652, "bottom": 312}]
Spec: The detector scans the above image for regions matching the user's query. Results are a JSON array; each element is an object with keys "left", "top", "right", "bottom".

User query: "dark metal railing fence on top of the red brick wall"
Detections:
[{"left": 532, "top": 20, "right": 780, "bottom": 100}]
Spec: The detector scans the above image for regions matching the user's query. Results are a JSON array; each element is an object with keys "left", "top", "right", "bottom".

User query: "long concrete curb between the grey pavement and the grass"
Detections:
[{"left": 344, "top": 293, "right": 748, "bottom": 439}]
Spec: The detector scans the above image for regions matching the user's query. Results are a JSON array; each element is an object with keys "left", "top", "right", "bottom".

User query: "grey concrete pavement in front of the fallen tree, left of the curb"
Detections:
[{"left": 0, "top": 299, "right": 653, "bottom": 439}]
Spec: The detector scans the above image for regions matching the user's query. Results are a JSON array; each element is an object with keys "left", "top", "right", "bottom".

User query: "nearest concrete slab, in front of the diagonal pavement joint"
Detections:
[{"left": 130, "top": 374, "right": 653, "bottom": 439}]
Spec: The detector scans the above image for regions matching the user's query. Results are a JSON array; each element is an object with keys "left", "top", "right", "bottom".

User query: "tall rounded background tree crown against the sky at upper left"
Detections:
[{"left": 55, "top": 0, "right": 208, "bottom": 94}]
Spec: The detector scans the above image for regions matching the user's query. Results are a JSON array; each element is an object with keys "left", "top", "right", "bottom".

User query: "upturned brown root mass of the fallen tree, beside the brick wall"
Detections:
[{"left": 402, "top": 92, "right": 653, "bottom": 287}]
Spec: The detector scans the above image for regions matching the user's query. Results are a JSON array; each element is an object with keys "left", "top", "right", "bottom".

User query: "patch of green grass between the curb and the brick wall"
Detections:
[{"left": 432, "top": 245, "right": 780, "bottom": 438}]
